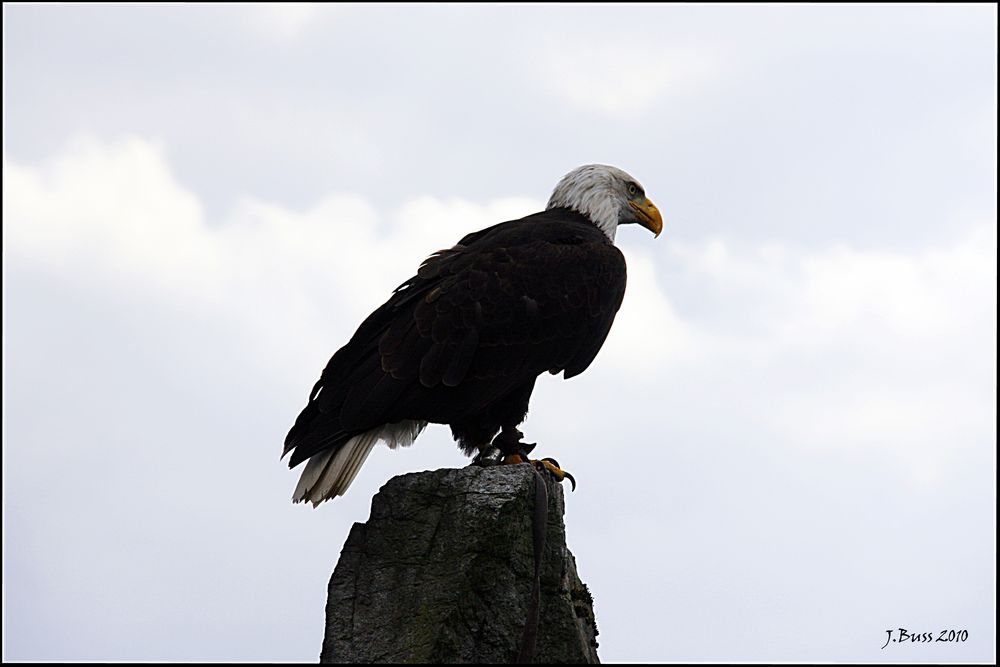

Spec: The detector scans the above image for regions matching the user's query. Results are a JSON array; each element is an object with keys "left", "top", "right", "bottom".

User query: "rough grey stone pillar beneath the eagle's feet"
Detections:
[{"left": 320, "top": 465, "right": 598, "bottom": 663}]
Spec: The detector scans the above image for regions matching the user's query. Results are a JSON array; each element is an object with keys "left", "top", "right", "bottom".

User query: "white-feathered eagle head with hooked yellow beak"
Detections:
[{"left": 546, "top": 164, "right": 663, "bottom": 241}]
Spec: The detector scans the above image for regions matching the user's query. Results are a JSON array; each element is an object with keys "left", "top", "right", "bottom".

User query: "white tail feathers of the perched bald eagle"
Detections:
[{"left": 292, "top": 420, "right": 427, "bottom": 507}]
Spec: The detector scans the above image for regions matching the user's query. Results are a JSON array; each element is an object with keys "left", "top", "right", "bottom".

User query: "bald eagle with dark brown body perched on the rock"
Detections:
[{"left": 282, "top": 165, "right": 663, "bottom": 507}]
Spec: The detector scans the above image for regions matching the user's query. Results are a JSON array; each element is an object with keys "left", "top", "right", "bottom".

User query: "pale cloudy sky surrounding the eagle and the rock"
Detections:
[{"left": 3, "top": 4, "right": 997, "bottom": 662}]
